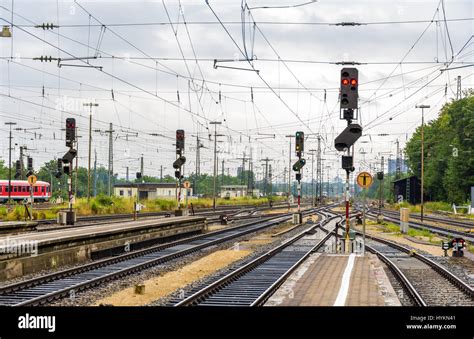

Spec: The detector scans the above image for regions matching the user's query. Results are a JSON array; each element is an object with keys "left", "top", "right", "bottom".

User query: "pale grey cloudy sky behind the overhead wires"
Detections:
[{"left": 0, "top": 0, "right": 474, "bottom": 185}]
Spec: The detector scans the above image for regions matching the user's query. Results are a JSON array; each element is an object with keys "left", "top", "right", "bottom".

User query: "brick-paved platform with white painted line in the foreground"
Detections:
[{"left": 265, "top": 253, "right": 400, "bottom": 306}]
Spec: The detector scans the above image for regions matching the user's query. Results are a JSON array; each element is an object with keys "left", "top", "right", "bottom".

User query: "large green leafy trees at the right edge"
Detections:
[{"left": 405, "top": 92, "right": 474, "bottom": 203}]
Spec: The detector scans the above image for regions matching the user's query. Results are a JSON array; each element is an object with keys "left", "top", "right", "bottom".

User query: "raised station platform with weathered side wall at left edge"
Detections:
[{"left": 0, "top": 216, "right": 206, "bottom": 281}]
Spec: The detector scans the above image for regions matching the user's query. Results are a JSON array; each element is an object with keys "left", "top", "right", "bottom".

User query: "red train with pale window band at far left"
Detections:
[{"left": 0, "top": 180, "right": 51, "bottom": 202}]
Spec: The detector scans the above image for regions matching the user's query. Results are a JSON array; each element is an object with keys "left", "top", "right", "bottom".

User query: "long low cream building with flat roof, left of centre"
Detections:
[{"left": 114, "top": 182, "right": 193, "bottom": 199}]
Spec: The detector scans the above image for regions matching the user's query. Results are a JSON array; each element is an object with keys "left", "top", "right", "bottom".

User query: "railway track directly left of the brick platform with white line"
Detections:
[{"left": 170, "top": 216, "right": 340, "bottom": 306}]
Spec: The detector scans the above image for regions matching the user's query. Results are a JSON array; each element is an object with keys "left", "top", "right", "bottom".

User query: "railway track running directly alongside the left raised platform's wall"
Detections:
[{"left": 0, "top": 209, "right": 322, "bottom": 306}]
